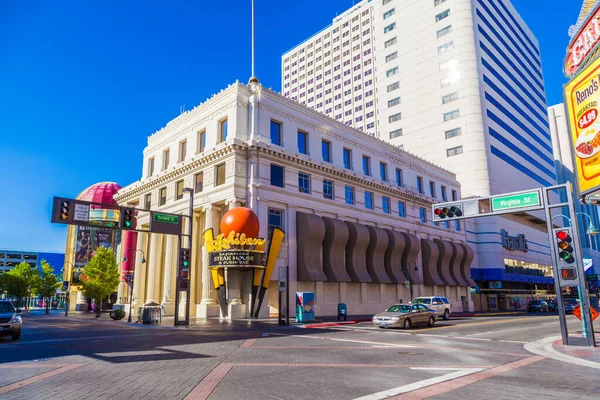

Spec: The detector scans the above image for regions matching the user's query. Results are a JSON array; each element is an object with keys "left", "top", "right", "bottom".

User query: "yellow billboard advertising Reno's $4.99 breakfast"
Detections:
[{"left": 564, "top": 55, "right": 600, "bottom": 196}]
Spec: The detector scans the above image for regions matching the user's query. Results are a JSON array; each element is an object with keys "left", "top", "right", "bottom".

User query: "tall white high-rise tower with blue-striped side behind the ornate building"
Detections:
[{"left": 282, "top": 0, "right": 556, "bottom": 306}]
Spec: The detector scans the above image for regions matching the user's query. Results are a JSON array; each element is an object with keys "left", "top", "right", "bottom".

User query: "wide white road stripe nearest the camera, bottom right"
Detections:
[{"left": 391, "top": 356, "right": 545, "bottom": 400}]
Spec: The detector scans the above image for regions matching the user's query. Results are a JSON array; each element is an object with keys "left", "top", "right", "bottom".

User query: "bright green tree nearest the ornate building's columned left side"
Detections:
[{"left": 81, "top": 247, "right": 121, "bottom": 318}]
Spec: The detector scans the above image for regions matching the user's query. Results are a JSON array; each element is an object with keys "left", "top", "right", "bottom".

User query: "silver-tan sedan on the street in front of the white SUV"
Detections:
[{"left": 373, "top": 304, "right": 437, "bottom": 329}]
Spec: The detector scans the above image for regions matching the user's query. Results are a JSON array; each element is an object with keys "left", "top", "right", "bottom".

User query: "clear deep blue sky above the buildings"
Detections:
[{"left": 0, "top": 0, "right": 582, "bottom": 251}]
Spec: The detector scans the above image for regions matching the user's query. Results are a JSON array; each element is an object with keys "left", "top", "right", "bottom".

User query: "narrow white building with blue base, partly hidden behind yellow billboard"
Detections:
[{"left": 548, "top": 103, "right": 600, "bottom": 273}]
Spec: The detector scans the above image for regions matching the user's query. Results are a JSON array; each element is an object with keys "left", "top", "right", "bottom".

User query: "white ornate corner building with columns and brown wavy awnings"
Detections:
[{"left": 115, "top": 83, "right": 474, "bottom": 316}]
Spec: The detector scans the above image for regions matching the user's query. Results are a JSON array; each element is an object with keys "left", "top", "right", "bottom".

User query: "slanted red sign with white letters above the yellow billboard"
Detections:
[{"left": 565, "top": 7, "right": 600, "bottom": 76}]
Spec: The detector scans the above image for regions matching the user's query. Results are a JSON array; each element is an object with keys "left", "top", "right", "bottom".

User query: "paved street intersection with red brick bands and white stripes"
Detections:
[{"left": 0, "top": 314, "right": 600, "bottom": 400}]
